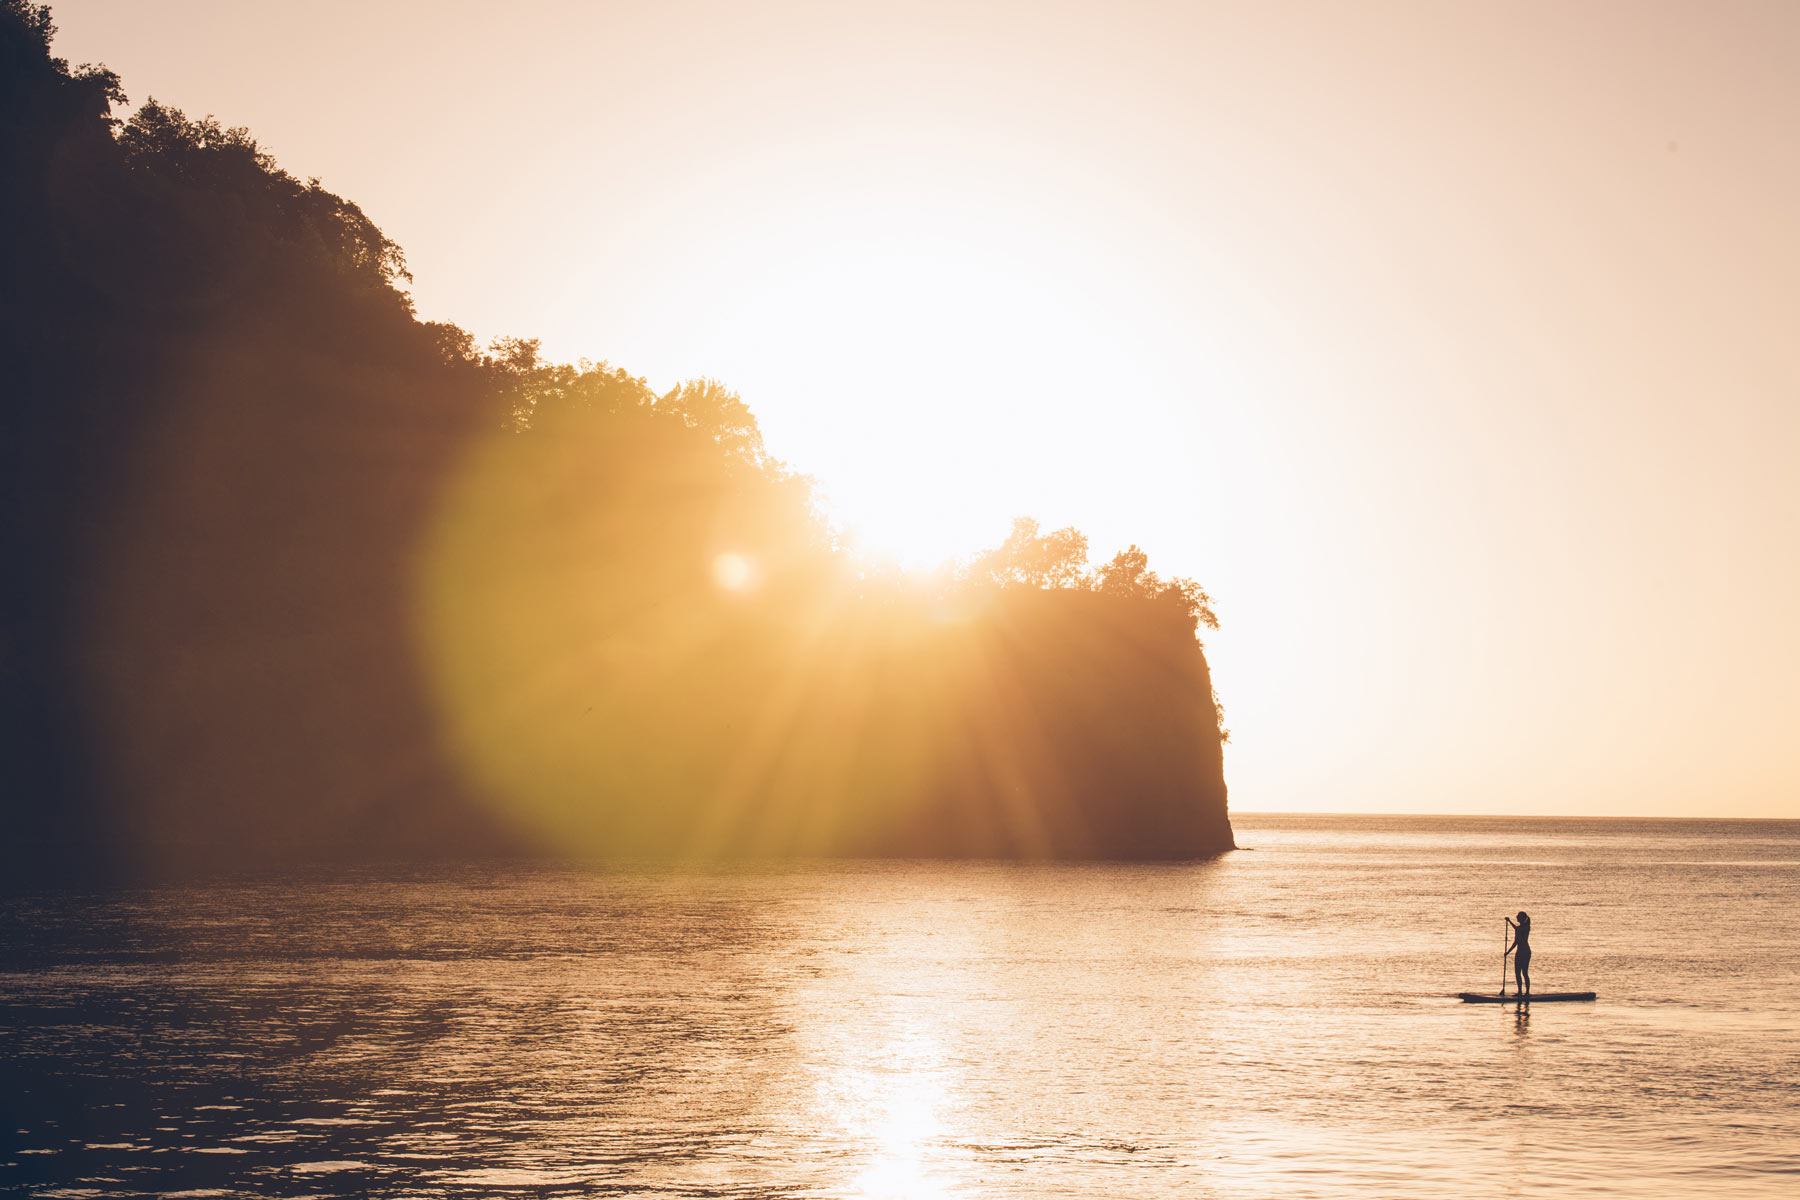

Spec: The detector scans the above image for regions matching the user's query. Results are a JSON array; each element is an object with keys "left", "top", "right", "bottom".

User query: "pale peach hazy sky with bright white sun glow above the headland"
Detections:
[{"left": 54, "top": 0, "right": 1800, "bottom": 817}]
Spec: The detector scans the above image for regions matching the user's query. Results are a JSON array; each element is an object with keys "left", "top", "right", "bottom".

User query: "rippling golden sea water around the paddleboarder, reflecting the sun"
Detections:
[{"left": 0, "top": 815, "right": 1800, "bottom": 1198}]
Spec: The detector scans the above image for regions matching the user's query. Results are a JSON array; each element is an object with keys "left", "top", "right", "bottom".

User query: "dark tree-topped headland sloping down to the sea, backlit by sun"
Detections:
[{"left": 0, "top": 0, "right": 1229, "bottom": 878}]
